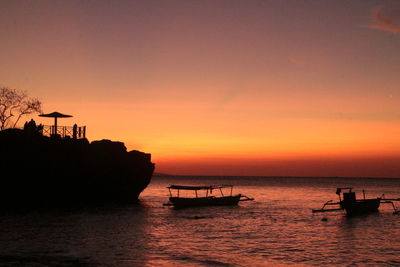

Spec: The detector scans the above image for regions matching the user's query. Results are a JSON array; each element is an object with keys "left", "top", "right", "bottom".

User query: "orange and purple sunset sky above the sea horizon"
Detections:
[{"left": 0, "top": 0, "right": 400, "bottom": 177}]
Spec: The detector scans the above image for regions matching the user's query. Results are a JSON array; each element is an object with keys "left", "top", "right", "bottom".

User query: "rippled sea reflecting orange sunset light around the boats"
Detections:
[{"left": 0, "top": 176, "right": 400, "bottom": 267}]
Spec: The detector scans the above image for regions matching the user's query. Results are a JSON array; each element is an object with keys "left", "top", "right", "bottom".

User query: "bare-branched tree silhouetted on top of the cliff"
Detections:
[{"left": 0, "top": 87, "right": 42, "bottom": 130}]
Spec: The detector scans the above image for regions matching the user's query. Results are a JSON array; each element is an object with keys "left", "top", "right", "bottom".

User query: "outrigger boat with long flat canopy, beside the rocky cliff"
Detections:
[{"left": 164, "top": 185, "right": 254, "bottom": 208}]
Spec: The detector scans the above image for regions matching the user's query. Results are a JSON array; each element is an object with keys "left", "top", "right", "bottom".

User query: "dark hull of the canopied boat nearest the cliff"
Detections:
[{"left": 169, "top": 195, "right": 241, "bottom": 208}]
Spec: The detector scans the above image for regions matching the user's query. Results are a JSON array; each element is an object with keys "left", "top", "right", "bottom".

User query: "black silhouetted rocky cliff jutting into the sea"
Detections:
[{"left": 0, "top": 129, "right": 154, "bottom": 208}]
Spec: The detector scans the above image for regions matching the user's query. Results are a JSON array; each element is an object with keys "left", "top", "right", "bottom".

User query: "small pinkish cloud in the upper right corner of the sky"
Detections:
[{"left": 369, "top": 7, "right": 400, "bottom": 34}]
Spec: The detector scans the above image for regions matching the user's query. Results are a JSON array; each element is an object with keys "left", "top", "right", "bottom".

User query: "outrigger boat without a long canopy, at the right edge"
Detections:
[{"left": 312, "top": 187, "right": 400, "bottom": 216}]
